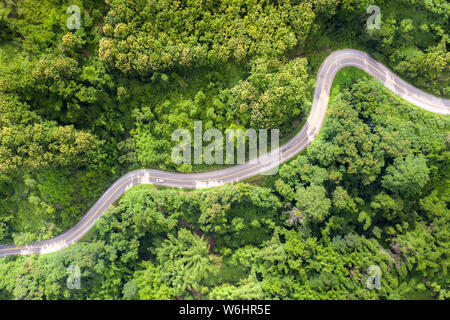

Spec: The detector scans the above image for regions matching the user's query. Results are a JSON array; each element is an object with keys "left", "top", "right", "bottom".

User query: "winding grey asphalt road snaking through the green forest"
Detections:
[{"left": 0, "top": 49, "right": 450, "bottom": 257}]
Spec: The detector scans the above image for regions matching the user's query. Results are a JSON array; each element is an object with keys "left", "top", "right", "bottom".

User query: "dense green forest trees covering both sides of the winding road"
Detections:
[{"left": 0, "top": 0, "right": 450, "bottom": 299}]
